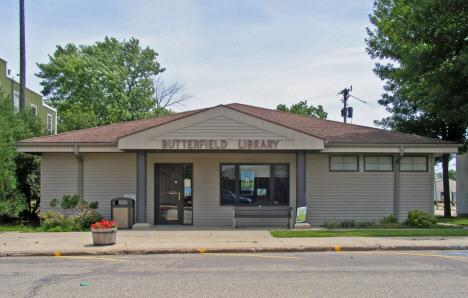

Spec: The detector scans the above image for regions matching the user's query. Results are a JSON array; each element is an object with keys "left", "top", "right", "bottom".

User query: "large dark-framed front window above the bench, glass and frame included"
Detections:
[{"left": 220, "top": 164, "right": 289, "bottom": 206}]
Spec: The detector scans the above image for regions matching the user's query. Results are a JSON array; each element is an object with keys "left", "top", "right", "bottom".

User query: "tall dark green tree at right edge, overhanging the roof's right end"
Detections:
[{"left": 366, "top": 0, "right": 468, "bottom": 217}]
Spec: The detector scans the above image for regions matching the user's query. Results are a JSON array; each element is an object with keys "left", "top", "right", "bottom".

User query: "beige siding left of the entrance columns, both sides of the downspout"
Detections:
[{"left": 41, "top": 153, "right": 136, "bottom": 219}]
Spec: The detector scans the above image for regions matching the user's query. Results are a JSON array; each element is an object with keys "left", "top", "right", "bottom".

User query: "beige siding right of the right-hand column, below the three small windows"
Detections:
[{"left": 306, "top": 154, "right": 433, "bottom": 225}]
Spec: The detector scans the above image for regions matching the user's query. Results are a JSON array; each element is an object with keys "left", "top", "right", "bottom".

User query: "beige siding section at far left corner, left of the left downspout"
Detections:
[{"left": 41, "top": 153, "right": 78, "bottom": 212}]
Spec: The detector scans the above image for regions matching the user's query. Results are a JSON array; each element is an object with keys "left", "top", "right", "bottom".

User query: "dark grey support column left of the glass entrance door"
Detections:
[{"left": 133, "top": 150, "right": 150, "bottom": 229}]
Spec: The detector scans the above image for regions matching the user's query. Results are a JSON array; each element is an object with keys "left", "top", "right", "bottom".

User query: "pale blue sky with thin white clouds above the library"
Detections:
[{"left": 0, "top": 0, "right": 389, "bottom": 126}]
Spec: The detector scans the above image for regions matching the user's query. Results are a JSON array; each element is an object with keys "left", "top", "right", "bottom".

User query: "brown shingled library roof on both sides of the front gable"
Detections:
[{"left": 18, "top": 103, "right": 455, "bottom": 145}]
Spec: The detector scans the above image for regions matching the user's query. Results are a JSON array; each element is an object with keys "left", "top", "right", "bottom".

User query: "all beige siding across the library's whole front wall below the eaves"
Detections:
[{"left": 41, "top": 153, "right": 433, "bottom": 226}]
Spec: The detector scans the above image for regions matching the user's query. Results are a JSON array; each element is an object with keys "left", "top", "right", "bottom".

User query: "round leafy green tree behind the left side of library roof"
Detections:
[{"left": 36, "top": 37, "right": 183, "bottom": 132}]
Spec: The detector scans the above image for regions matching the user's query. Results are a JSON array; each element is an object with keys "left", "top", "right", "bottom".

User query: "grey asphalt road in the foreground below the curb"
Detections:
[{"left": 0, "top": 251, "right": 468, "bottom": 297}]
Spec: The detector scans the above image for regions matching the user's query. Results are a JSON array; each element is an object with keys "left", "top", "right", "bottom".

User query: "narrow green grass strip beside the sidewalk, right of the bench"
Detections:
[{"left": 270, "top": 229, "right": 468, "bottom": 238}]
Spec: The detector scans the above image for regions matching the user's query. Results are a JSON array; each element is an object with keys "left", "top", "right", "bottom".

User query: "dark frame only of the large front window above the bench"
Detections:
[{"left": 218, "top": 163, "right": 291, "bottom": 206}]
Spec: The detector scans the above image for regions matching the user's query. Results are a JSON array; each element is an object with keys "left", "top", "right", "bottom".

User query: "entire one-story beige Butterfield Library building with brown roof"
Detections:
[{"left": 16, "top": 104, "right": 459, "bottom": 227}]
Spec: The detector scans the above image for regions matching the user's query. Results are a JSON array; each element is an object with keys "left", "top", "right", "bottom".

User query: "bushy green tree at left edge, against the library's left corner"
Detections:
[{"left": 0, "top": 89, "right": 46, "bottom": 218}]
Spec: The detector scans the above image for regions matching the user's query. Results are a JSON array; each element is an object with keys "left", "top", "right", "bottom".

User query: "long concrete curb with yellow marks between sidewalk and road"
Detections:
[{"left": 0, "top": 245, "right": 468, "bottom": 257}]
